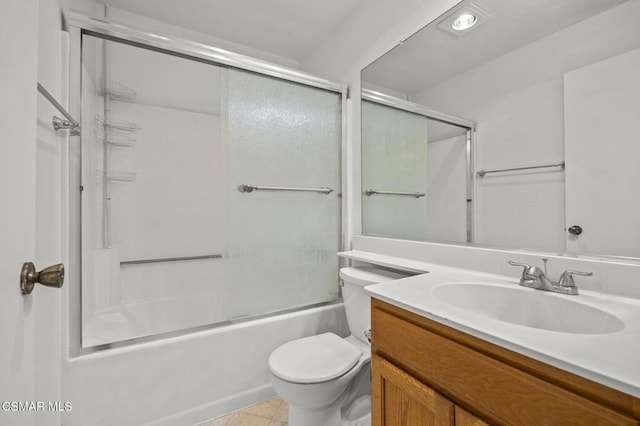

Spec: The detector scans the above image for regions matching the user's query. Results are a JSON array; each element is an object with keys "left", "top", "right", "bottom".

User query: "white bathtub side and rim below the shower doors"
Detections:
[{"left": 62, "top": 303, "right": 348, "bottom": 426}]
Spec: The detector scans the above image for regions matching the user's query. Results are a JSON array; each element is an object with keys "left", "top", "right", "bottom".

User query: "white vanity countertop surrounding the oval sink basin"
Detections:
[{"left": 365, "top": 262, "right": 640, "bottom": 397}]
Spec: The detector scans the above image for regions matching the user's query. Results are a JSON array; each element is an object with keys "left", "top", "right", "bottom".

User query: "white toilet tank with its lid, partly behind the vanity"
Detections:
[{"left": 340, "top": 266, "right": 412, "bottom": 343}]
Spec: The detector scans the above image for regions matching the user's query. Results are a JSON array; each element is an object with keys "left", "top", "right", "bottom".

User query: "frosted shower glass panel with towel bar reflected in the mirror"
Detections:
[{"left": 362, "top": 101, "right": 429, "bottom": 240}]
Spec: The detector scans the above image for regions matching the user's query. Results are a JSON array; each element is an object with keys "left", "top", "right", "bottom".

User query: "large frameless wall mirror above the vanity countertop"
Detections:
[{"left": 362, "top": 0, "right": 640, "bottom": 259}]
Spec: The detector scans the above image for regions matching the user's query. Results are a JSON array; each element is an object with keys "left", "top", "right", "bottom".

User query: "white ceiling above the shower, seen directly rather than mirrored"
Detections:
[{"left": 98, "top": 0, "right": 364, "bottom": 61}]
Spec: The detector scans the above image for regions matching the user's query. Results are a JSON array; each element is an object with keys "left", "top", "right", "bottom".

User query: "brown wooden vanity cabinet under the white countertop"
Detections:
[{"left": 371, "top": 299, "right": 640, "bottom": 426}]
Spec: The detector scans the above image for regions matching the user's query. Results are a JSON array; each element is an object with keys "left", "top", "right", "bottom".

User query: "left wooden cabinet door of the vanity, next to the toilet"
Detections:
[{"left": 372, "top": 355, "right": 454, "bottom": 426}]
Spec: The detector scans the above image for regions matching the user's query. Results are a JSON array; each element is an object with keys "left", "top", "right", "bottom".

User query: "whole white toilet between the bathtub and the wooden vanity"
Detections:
[{"left": 269, "top": 266, "right": 407, "bottom": 426}]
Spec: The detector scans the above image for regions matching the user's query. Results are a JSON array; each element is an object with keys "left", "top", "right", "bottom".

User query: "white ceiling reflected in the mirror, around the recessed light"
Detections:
[{"left": 362, "top": 0, "right": 628, "bottom": 95}]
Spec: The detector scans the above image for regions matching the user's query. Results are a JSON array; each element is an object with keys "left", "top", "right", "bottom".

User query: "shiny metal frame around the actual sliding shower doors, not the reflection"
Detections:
[{"left": 68, "top": 12, "right": 350, "bottom": 357}]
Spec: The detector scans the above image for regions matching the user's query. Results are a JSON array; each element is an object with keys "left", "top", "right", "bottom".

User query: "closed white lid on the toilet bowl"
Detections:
[{"left": 269, "top": 333, "right": 362, "bottom": 383}]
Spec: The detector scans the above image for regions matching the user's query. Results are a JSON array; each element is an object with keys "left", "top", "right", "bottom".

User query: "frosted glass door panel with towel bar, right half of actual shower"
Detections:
[{"left": 226, "top": 70, "right": 341, "bottom": 318}]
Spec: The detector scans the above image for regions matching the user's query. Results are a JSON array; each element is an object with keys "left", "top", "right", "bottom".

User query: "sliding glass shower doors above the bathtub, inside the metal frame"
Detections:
[{"left": 81, "top": 35, "right": 342, "bottom": 347}]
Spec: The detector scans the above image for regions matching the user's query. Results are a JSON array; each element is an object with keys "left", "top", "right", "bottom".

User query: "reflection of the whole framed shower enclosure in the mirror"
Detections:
[{"left": 362, "top": 91, "right": 474, "bottom": 243}]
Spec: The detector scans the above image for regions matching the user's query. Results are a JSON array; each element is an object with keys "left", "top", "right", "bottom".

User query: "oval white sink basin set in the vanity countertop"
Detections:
[{"left": 432, "top": 283, "right": 624, "bottom": 334}]
